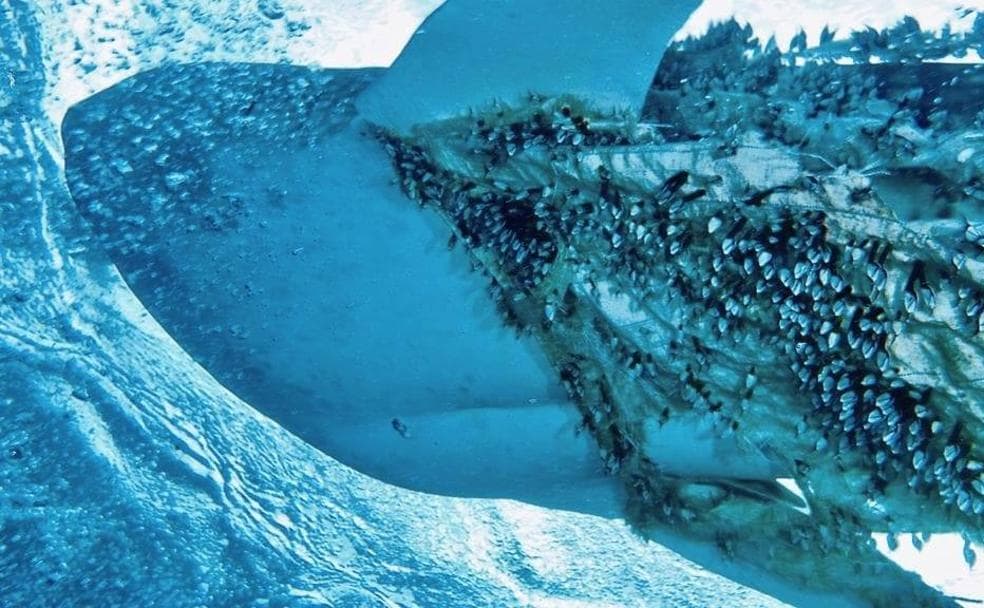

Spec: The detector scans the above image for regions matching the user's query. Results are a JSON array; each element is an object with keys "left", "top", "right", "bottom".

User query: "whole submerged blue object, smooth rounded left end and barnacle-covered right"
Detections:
[{"left": 63, "top": 2, "right": 984, "bottom": 605}]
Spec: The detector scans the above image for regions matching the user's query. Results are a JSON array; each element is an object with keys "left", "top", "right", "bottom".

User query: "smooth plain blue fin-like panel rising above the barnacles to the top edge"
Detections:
[{"left": 356, "top": 0, "right": 700, "bottom": 133}]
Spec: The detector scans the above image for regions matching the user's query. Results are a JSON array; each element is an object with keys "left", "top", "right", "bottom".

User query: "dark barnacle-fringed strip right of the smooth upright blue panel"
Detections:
[{"left": 644, "top": 13, "right": 984, "bottom": 208}]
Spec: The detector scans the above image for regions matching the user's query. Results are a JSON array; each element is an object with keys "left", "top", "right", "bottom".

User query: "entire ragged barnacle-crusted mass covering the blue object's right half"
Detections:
[{"left": 381, "top": 16, "right": 984, "bottom": 605}]
